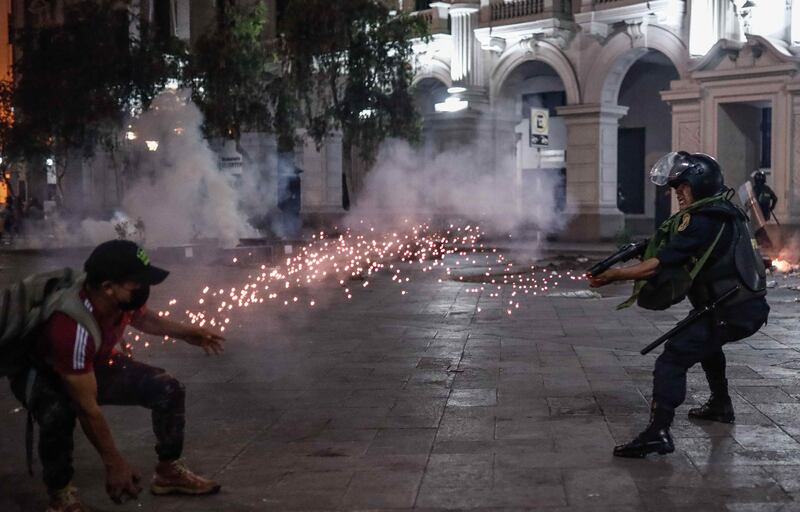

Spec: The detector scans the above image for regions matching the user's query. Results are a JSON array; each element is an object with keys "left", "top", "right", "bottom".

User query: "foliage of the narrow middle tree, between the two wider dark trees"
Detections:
[{"left": 185, "top": 2, "right": 277, "bottom": 140}]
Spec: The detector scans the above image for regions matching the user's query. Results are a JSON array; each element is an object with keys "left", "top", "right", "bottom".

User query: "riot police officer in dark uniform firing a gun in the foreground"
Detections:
[{"left": 589, "top": 151, "right": 769, "bottom": 457}]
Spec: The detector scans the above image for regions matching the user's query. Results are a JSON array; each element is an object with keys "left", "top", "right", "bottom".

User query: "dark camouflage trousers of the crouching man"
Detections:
[{"left": 11, "top": 356, "right": 185, "bottom": 489}]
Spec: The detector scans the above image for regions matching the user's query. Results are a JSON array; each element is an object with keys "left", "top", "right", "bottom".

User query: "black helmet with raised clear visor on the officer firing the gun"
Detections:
[{"left": 650, "top": 151, "right": 725, "bottom": 199}]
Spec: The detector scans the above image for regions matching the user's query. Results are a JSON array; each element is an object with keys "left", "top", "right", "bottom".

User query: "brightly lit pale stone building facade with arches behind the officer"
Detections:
[{"left": 406, "top": 0, "right": 800, "bottom": 240}]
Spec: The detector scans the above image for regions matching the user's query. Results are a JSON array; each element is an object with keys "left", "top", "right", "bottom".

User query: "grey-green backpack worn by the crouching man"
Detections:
[{"left": 0, "top": 268, "right": 102, "bottom": 377}]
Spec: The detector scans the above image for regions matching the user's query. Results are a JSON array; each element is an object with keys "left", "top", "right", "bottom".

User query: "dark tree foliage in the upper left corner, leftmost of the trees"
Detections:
[{"left": 4, "top": 0, "right": 185, "bottom": 163}]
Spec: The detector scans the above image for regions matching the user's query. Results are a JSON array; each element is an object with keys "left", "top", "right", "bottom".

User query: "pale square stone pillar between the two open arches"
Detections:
[{"left": 558, "top": 104, "right": 628, "bottom": 240}]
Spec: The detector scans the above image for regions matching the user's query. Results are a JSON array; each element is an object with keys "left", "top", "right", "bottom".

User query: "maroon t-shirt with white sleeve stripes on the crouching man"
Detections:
[{"left": 38, "top": 292, "right": 146, "bottom": 374}]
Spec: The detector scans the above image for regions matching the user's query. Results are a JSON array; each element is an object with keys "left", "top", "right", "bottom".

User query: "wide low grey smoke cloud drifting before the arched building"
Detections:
[{"left": 347, "top": 140, "right": 569, "bottom": 235}]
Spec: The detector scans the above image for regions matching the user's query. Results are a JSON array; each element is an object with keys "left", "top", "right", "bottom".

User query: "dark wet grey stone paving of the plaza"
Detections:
[{"left": 0, "top": 250, "right": 800, "bottom": 512}]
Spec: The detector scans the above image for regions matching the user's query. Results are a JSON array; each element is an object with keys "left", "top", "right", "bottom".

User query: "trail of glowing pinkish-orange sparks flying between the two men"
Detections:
[{"left": 124, "top": 221, "right": 580, "bottom": 350}]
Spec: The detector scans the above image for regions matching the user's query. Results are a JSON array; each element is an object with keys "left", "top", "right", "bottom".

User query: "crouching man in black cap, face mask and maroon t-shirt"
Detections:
[{"left": 11, "top": 240, "right": 224, "bottom": 512}]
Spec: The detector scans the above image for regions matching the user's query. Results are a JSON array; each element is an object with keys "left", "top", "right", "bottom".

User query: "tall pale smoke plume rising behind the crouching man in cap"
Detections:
[{"left": 81, "top": 91, "right": 255, "bottom": 246}]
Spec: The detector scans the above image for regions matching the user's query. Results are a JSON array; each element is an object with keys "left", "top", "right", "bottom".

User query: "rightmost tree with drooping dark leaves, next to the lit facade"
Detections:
[{"left": 278, "top": 0, "right": 428, "bottom": 202}]
